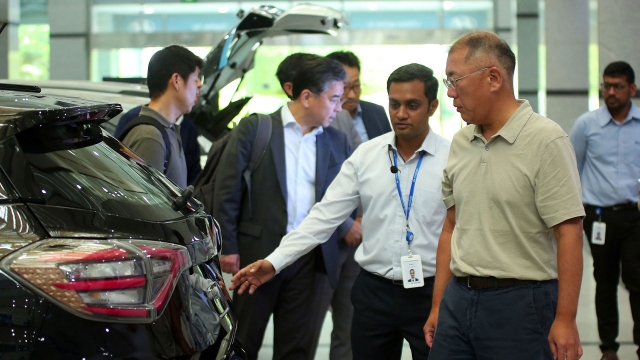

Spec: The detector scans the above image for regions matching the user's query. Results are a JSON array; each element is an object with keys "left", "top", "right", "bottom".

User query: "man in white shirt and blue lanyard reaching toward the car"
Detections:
[{"left": 230, "top": 64, "right": 450, "bottom": 360}]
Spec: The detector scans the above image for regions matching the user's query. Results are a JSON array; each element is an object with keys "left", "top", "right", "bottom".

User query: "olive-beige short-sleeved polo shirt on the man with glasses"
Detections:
[{"left": 442, "top": 100, "right": 584, "bottom": 280}]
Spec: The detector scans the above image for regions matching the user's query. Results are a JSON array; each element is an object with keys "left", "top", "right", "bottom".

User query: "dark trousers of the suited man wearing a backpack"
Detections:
[{"left": 233, "top": 251, "right": 326, "bottom": 360}]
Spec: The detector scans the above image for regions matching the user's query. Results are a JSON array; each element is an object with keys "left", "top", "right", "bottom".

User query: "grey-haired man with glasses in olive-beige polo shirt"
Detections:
[{"left": 424, "top": 32, "right": 584, "bottom": 360}]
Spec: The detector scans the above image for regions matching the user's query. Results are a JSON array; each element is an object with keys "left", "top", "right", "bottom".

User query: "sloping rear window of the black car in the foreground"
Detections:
[{"left": 10, "top": 123, "right": 189, "bottom": 221}]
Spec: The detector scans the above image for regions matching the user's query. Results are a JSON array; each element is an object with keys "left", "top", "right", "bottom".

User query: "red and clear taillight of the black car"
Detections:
[{"left": 0, "top": 239, "right": 191, "bottom": 322}]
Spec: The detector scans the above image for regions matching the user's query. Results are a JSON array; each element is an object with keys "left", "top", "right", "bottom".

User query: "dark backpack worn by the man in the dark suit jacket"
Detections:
[{"left": 193, "top": 114, "right": 272, "bottom": 214}]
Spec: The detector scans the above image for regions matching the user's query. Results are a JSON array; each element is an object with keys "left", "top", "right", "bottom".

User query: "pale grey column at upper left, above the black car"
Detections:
[{"left": 48, "top": 0, "right": 90, "bottom": 80}]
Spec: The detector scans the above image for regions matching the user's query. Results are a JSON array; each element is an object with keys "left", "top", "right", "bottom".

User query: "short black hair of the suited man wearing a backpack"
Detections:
[{"left": 291, "top": 57, "right": 347, "bottom": 100}]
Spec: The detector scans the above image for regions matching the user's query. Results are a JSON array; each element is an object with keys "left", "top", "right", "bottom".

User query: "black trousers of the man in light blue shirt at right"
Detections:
[{"left": 584, "top": 205, "right": 640, "bottom": 356}]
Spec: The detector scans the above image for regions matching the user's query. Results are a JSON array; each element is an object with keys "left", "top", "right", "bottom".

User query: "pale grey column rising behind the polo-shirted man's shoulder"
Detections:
[{"left": 544, "top": 0, "right": 592, "bottom": 132}]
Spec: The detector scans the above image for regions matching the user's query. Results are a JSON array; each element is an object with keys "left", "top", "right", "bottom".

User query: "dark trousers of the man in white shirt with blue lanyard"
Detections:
[{"left": 351, "top": 270, "right": 433, "bottom": 360}]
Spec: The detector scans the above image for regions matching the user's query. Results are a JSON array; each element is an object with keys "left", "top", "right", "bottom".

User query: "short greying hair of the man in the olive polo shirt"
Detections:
[{"left": 449, "top": 31, "right": 516, "bottom": 82}]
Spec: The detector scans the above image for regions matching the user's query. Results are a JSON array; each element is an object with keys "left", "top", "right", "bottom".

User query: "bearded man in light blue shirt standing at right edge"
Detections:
[{"left": 571, "top": 61, "right": 640, "bottom": 360}]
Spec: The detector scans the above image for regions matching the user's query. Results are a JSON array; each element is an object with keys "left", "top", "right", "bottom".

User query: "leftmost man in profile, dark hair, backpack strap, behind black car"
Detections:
[{"left": 120, "top": 45, "right": 202, "bottom": 188}]
